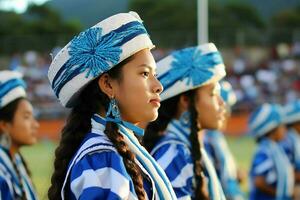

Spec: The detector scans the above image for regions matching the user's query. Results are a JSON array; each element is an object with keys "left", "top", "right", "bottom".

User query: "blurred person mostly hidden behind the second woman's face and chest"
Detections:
[{"left": 204, "top": 81, "right": 244, "bottom": 200}]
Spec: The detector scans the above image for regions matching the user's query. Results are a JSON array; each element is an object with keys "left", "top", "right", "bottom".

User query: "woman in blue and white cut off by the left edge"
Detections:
[{"left": 0, "top": 71, "right": 39, "bottom": 200}]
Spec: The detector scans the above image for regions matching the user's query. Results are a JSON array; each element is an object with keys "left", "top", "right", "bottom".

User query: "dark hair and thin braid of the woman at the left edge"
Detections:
[{"left": 0, "top": 97, "right": 31, "bottom": 199}]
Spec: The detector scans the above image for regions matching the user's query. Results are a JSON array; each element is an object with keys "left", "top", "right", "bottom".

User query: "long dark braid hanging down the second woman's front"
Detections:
[{"left": 189, "top": 91, "right": 209, "bottom": 200}]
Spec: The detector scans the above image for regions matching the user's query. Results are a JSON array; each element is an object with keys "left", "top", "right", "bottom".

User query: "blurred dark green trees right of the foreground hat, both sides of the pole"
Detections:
[{"left": 129, "top": 0, "right": 300, "bottom": 47}]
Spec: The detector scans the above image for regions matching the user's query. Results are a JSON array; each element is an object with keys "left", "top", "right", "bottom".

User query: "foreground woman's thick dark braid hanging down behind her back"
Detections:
[{"left": 48, "top": 79, "right": 104, "bottom": 200}]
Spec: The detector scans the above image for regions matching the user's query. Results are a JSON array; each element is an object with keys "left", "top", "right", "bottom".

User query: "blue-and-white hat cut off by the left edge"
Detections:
[{"left": 0, "top": 70, "right": 26, "bottom": 109}]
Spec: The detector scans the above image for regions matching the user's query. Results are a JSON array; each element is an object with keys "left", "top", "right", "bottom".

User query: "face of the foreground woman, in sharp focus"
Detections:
[{"left": 113, "top": 49, "right": 163, "bottom": 124}]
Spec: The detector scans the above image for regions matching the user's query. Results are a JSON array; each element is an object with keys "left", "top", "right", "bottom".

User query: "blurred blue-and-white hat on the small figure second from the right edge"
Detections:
[{"left": 248, "top": 103, "right": 283, "bottom": 138}]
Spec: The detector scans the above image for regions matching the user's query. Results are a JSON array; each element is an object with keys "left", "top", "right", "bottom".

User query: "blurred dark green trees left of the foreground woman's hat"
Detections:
[{"left": 0, "top": 4, "right": 81, "bottom": 54}]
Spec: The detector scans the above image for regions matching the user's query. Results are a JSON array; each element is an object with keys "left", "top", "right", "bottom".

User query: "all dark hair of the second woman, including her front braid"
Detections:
[{"left": 143, "top": 90, "right": 209, "bottom": 200}]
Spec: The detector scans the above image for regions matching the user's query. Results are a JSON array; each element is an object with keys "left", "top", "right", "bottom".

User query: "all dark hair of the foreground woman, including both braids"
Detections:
[{"left": 48, "top": 58, "right": 145, "bottom": 200}]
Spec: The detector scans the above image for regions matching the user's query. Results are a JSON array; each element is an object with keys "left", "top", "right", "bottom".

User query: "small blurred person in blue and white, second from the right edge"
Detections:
[{"left": 249, "top": 103, "right": 294, "bottom": 200}]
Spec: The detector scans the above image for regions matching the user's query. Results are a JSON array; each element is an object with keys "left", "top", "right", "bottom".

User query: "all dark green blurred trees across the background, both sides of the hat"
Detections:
[{"left": 0, "top": 0, "right": 300, "bottom": 54}]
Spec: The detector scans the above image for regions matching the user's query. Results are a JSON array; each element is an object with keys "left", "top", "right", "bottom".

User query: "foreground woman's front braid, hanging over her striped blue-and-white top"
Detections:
[{"left": 104, "top": 122, "right": 146, "bottom": 200}]
